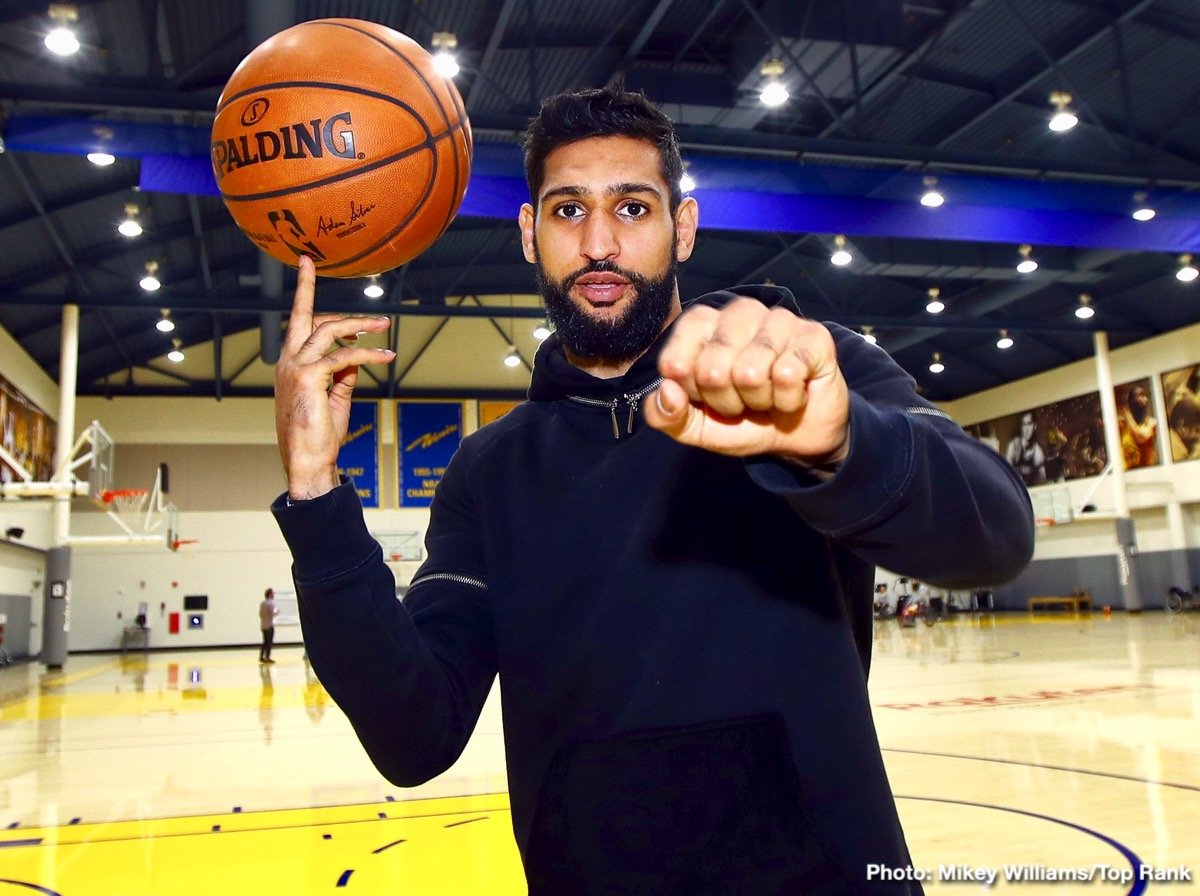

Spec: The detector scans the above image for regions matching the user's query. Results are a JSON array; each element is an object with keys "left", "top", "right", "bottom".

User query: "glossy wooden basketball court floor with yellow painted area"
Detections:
[{"left": 0, "top": 612, "right": 1200, "bottom": 896}]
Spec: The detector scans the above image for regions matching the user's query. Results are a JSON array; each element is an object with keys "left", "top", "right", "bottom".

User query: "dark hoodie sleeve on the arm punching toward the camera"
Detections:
[{"left": 697, "top": 287, "right": 1034, "bottom": 588}]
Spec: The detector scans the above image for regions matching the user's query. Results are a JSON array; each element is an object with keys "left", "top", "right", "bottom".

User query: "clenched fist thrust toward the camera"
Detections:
[{"left": 644, "top": 297, "right": 850, "bottom": 475}]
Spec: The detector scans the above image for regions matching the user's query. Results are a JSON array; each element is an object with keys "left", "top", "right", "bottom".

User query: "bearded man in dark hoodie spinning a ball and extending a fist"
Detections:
[{"left": 271, "top": 86, "right": 1033, "bottom": 896}]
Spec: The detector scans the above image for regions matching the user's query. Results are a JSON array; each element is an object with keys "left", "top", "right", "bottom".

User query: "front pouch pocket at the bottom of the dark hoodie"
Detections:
[{"left": 526, "top": 714, "right": 851, "bottom": 896}]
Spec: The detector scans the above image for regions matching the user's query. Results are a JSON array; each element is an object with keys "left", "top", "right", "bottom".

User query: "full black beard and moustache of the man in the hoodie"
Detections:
[{"left": 535, "top": 251, "right": 679, "bottom": 362}]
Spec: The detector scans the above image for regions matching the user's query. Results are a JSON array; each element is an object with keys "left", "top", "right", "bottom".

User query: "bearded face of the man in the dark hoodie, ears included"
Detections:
[{"left": 520, "top": 137, "right": 696, "bottom": 361}]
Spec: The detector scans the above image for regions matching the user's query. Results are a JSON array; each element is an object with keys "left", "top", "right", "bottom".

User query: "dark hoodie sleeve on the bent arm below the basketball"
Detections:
[{"left": 271, "top": 461, "right": 497, "bottom": 787}]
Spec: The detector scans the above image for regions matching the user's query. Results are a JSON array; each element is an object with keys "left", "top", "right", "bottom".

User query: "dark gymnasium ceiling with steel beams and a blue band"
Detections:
[{"left": 0, "top": 0, "right": 1200, "bottom": 399}]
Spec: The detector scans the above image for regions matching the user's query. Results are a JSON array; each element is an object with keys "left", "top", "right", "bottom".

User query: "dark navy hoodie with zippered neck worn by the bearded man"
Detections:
[{"left": 272, "top": 287, "right": 1033, "bottom": 896}]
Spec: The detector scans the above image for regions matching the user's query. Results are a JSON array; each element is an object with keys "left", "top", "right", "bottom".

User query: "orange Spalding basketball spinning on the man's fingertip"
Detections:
[{"left": 211, "top": 19, "right": 473, "bottom": 277}]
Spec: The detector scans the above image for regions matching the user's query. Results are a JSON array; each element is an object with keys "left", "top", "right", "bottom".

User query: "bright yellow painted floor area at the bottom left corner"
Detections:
[{"left": 0, "top": 794, "right": 526, "bottom": 896}]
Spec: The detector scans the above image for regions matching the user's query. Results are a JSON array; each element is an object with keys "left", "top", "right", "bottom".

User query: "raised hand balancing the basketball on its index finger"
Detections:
[{"left": 275, "top": 257, "right": 396, "bottom": 500}]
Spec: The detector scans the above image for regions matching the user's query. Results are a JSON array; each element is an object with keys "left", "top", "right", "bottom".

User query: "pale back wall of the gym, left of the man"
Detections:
[{"left": 62, "top": 398, "right": 476, "bottom": 650}]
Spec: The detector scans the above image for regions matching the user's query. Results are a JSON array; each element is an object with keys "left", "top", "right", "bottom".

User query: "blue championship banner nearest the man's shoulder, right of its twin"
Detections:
[{"left": 396, "top": 402, "right": 462, "bottom": 507}]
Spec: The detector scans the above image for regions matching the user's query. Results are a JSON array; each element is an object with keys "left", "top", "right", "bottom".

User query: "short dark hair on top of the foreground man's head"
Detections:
[{"left": 524, "top": 85, "right": 683, "bottom": 214}]
